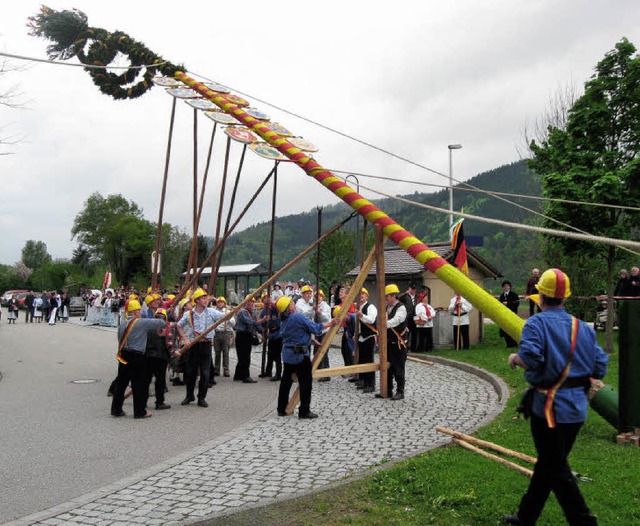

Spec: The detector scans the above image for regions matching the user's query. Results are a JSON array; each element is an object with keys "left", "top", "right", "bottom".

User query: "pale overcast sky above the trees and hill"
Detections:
[{"left": 0, "top": 0, "right": 640, "bottom": 264}]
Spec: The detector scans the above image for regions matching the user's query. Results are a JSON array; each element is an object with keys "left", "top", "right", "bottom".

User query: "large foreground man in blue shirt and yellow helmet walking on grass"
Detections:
[{"left": 504, "top": 268, "right": 608, "bottom": 525}]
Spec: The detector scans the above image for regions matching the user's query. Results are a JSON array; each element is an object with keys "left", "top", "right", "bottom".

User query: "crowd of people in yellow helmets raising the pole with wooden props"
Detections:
[{"left": 109, "top": 284, "right": 435, "bottom": 419}]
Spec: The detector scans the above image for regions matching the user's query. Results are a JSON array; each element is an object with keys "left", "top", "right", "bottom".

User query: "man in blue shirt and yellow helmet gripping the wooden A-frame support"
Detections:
[{"left": 276, "top": 296, "right": 338, "bottom": 418}]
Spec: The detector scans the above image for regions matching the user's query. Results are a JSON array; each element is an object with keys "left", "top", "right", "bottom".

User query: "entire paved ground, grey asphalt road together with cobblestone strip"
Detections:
[{"left": 0, "top": 318, "right": 506, "bottom": 525}]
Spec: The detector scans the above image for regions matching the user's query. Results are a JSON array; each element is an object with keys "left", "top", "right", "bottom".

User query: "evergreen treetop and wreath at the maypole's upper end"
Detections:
[{"left": 27, "top": 6, "right": 185, "bottom": 99}]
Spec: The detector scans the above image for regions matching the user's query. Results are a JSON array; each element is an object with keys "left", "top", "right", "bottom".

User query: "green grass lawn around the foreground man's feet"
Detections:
[{"left": 207, "top": 326, "right": 640, "bottom": 526}]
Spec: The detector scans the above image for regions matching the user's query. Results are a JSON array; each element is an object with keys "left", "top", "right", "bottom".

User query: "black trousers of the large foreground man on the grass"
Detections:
[{"left": 518, "top": 415, "right": 597, "bottom": 526}]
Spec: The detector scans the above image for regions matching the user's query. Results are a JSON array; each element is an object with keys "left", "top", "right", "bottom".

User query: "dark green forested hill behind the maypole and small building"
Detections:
[{"left": 218, "top": 161, "right": 543, "bottom": 292}]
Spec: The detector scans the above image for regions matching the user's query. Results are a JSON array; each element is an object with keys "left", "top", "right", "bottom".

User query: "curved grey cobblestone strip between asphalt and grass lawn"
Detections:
[{"left": 11, "top": 350, "right": 506, "bottom": 526}]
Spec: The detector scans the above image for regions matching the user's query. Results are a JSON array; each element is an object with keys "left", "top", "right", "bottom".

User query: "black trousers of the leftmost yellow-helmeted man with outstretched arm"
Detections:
[{"left": 111, "top": 350, "right": 149, "bottom": 417}]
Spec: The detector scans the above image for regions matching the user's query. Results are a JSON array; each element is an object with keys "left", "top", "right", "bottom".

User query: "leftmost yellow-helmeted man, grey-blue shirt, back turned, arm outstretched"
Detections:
[{"left": 111, "top": 299, "right": 170, "bottom": 418}]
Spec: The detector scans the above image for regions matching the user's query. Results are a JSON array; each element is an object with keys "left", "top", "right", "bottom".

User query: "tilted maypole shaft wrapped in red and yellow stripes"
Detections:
[{"left": 175, "top": 71, "right": 524, "bottom": 340}]
